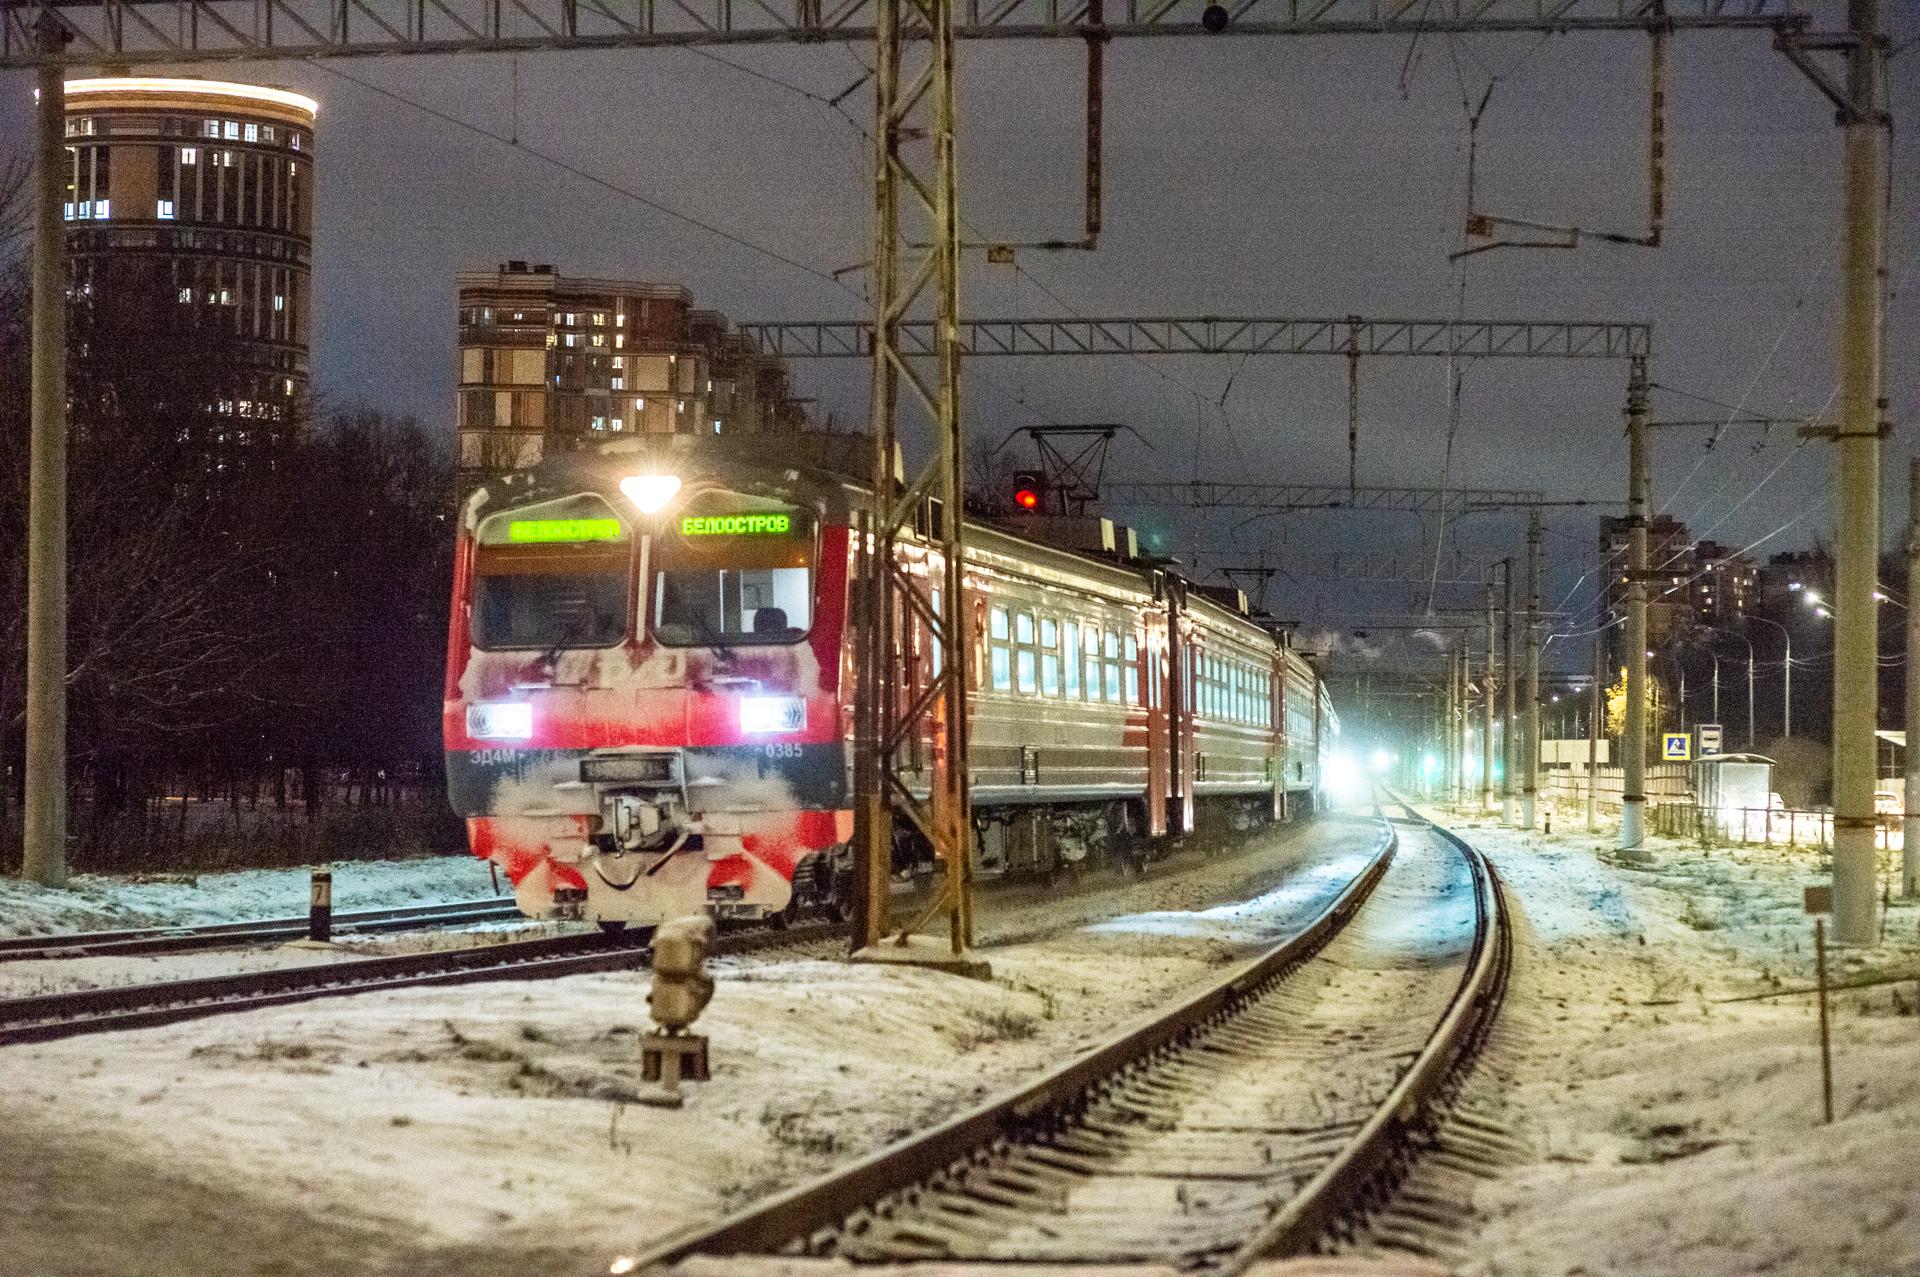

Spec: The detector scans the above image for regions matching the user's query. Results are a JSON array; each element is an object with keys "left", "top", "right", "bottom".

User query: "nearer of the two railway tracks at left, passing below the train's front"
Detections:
[{"left": 0, "top": 922, "right": 843, "bottom": 1047}]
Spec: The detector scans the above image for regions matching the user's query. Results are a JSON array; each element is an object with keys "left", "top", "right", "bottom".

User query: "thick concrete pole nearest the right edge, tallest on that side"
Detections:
[{"left": 1834, "top": 0, "right": 1891, "bottom": 945}]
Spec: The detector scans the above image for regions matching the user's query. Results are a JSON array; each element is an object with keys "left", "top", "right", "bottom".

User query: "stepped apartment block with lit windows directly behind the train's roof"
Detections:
[{"left": 457, "top": 261, "right": 806, "bottom": 476}]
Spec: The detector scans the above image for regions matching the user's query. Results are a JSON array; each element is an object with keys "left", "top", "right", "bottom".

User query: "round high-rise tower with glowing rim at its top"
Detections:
[{"left": 65, "top": 75, "right": 317, "bottom": 447}]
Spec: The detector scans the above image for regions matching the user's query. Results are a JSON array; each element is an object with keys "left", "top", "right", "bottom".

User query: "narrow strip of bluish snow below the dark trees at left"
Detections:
[{"left": 0, "top": 855, "right": 497, "bottom": 935}]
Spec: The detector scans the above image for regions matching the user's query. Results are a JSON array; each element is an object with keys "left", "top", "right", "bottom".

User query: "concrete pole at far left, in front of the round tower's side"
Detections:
[{"left": 21, "top": 27, "right": 67, "bottom": 887}]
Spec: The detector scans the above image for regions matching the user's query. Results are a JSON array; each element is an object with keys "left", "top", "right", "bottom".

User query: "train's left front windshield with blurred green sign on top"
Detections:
[{"left": 472, "top": 494, "right": 634, "bottom": 651}]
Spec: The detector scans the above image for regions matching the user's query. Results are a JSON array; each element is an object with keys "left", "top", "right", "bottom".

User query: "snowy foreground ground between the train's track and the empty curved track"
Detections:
[{"left": 0, "top": 818, "right": 1379, "bottom": 1277}]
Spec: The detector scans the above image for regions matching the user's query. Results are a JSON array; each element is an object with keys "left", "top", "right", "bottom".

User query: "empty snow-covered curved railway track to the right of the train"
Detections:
[{"left": 614, "top": 808, "right": 1509, "bottom": 1273}]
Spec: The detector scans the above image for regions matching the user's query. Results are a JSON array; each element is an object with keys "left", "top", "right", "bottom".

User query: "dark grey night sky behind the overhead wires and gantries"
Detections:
[{"left": 0, "top": 22, "right": 1920, "bottom": 664}]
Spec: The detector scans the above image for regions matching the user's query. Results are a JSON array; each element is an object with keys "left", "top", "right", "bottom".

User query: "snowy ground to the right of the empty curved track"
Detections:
[{"left": 1442, "top": 798, "right": 1920, "bottom": 1277}]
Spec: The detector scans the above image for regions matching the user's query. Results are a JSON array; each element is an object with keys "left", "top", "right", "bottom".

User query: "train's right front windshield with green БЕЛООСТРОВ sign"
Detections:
[{"left": 651, "top": 495, "right": 814, "bottom": 647}]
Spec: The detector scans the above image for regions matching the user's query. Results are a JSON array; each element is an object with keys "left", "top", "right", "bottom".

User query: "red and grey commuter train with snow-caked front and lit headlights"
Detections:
[{"left": 444, "top": 438, "right": 1338, "bottom": 929}]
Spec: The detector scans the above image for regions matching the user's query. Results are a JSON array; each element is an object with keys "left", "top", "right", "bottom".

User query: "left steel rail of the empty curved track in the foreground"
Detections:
[{"left": 628, "top": 810, "right": 1398, "bottom": 1271}]
